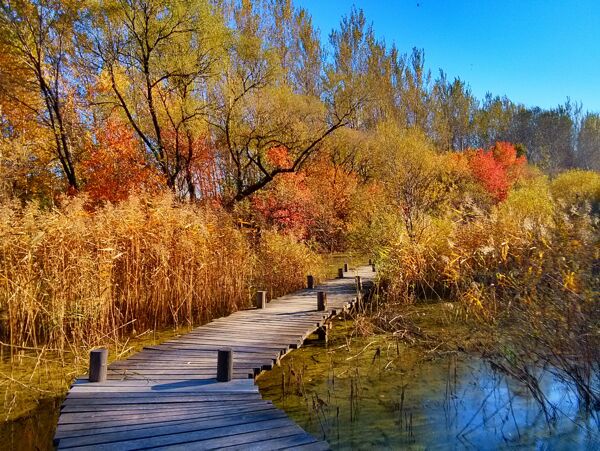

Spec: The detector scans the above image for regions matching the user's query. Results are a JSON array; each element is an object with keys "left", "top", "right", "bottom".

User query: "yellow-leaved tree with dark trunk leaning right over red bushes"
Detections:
[{"left": 209, "top": 2, "right": 356, "bottom": 206}]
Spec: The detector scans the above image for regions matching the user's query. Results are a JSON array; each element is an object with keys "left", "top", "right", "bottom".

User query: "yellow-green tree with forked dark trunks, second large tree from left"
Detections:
[{"left": 87, "top": 0, "right": 225, "bottom": 199}]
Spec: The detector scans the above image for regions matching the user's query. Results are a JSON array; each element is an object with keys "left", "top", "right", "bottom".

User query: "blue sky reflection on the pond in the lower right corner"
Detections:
[{"left": 414, "top": 360, "right": 600, "bottom": 449}]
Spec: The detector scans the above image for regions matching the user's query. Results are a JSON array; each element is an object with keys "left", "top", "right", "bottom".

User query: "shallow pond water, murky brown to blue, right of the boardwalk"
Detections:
[{"left": 259, "top": 327, "right": 600, "bottom": 451}]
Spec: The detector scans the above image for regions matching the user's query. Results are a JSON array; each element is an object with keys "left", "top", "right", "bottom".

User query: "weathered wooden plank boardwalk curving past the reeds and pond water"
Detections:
[{"left": 55, "top": 266, "right": 374, "bottom": 450}]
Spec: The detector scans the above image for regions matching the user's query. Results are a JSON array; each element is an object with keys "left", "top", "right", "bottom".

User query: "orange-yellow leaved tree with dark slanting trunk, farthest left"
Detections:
[{"left": 0, "top": 0, "right": 84, "bottom": 190}]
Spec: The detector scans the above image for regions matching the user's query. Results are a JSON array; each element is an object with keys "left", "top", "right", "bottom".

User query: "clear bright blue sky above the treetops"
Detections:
[{"left": 296, "top": 0, "right": 600, "bottom": 111}]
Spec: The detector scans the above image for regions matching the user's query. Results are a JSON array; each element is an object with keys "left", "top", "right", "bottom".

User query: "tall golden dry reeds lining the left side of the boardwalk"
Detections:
[{"left": 0, "top": 195, "right": 324, "bottom": 352}]
